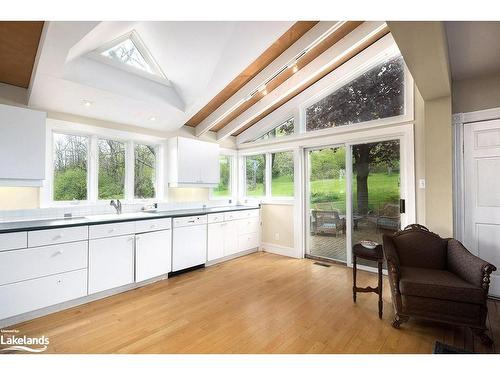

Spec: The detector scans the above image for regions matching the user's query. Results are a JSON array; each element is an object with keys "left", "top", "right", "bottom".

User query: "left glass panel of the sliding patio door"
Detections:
[{"left": 306, "top": 146, "right": 347, "bottom": 262}]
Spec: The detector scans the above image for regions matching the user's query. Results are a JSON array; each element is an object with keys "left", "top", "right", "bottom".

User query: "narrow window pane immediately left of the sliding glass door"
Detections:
[{"left": 270, "top": 151, "right": 294, "bottom": 197}]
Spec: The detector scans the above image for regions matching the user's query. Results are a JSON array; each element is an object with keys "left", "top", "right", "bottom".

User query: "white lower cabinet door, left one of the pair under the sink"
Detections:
[{"left": 89, "top": 235, "right": 135, "bottom": 294}]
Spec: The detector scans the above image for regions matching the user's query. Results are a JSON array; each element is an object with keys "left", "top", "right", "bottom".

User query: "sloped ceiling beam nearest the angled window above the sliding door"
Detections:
[{"left": 217, "top": 21, "right": 389, "bottom": 140}]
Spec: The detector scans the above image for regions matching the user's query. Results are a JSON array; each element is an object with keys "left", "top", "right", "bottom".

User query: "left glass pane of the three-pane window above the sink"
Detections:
[{"left": 53, "top": 133, "right": 89, "bottom": 201}]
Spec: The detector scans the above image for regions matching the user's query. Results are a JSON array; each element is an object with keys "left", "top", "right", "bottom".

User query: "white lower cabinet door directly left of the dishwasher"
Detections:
[{"left": 135, "top": 230, "right": 172, "bottom": 282}]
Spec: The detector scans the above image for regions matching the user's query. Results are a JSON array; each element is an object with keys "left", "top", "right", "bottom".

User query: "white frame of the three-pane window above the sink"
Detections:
[{"left": 40, "top": 119, "right": 165, "bottom": 208}]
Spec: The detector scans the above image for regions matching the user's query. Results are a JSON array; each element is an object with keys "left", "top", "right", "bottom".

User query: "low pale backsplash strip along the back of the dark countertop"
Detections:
[{"left": 0, "top": 200, "right": 230, "bottom": 221}]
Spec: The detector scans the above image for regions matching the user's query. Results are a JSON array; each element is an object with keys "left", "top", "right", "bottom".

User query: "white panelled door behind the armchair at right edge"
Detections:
[{"left": 464, "top": 120, "right": 500, "bottom": 296}]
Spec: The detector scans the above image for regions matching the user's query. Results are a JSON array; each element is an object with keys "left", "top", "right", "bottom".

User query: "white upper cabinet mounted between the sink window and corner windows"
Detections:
[{"left": 168, "top": 137, "right": 220, "bottom": 187}]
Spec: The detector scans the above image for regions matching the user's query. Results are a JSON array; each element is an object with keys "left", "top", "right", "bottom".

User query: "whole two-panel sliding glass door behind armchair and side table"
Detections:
[{"left": 306, "top": 139, "right": 401, "bottom": 265}]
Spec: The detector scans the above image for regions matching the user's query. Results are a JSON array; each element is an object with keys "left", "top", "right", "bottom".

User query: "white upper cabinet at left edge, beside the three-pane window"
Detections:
[{"left": 0, "top": 104, "right": 46, "bottom": 186}]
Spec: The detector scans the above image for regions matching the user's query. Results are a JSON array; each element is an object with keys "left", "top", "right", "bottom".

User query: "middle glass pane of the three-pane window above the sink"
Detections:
[{"left": 97, "top": 139, "right": 125, "bottom": 199}]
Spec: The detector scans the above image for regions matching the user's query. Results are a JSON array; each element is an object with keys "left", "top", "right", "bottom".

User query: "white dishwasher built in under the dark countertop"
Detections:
[{"left": 172, "top": 215, "right": 207, "bottom": 272}]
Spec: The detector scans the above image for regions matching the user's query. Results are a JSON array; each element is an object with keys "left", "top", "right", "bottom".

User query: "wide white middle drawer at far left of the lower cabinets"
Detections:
[{"left": 0, "top": 241, "right": 87, "bottom": 285}]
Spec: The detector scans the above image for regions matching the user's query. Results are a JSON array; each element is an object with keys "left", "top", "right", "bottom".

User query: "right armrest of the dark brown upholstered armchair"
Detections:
[{"left": 447, "top": 239, "right": 497, "bottom": 293}]
